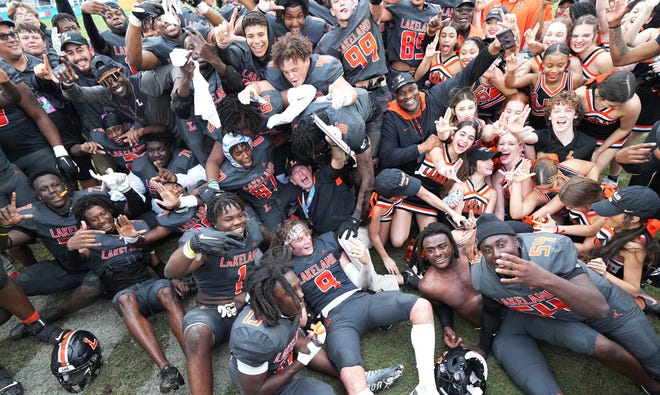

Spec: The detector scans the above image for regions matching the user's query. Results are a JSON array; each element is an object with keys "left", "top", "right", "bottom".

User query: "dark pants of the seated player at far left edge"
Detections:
[{"left": 14, "top": 259, "right": 101, "bottom": 296}]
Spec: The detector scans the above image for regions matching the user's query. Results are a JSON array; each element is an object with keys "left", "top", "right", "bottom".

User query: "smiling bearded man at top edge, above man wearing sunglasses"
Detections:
[{"left": 80, "top": 0, "right": 128, "bottom": 67}]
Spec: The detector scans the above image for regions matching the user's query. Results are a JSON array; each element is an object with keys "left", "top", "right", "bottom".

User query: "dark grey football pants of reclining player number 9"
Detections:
[{"left": 324, "top": 291, "right": 419, "bottom": 370}]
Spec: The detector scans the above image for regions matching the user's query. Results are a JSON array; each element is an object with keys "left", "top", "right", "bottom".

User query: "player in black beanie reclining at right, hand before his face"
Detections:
[{"left": 470, "top": 214, "right": 660, "bottom": 394}]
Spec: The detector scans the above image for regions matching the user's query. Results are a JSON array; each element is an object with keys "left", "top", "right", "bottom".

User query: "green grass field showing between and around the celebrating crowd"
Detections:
[{"left": 0, "top": 12, "right": 660, "bottom": 395}]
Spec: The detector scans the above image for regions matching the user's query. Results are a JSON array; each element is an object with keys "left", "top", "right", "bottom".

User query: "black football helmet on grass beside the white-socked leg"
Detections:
[{"left": 435, "top": 347, "right": 488, "bottom": 395}]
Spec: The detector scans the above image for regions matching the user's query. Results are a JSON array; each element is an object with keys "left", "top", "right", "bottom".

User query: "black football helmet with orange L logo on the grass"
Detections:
[{"left": 50, "top": 330, "right": 103, "bottom": 393}]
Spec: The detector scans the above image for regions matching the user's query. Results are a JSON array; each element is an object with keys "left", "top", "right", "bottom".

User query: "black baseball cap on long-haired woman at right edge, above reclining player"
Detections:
[{"left": 591, "top": 185, "right": 660, "bottom": 218}]
